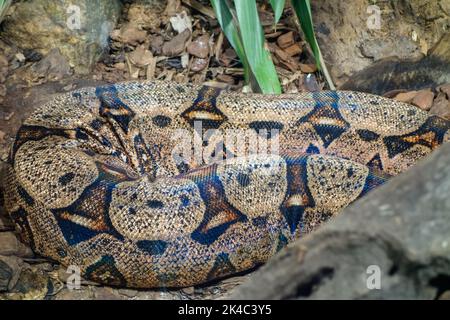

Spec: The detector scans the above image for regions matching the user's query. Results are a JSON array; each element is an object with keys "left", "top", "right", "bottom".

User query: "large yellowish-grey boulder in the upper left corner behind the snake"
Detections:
[{"left": 2, "top": 0, "right": 121, "bottom": 74}]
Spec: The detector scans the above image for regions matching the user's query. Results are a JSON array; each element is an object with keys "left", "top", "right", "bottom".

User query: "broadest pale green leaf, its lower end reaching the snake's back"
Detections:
[{"left": 234, "top": 0, "right": 281, "bottom": 94}]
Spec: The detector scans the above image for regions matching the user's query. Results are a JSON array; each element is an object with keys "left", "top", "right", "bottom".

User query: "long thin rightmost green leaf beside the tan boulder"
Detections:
[{"left": 291, "top": 0, "right": 335, "bottom": 90}]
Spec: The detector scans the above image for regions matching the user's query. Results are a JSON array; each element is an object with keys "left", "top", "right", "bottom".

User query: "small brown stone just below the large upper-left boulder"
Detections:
[{"left": 31, "top": 48, "right": 70, "bottom": 81}]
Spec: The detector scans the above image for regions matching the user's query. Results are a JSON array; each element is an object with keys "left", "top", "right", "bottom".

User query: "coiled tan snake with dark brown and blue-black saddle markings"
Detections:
[{"left": 4, "top": 81, "right": 450, "bottom": 288}]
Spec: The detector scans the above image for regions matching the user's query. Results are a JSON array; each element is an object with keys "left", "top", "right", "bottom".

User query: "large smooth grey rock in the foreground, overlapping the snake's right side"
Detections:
[{"left": 232, "top": 144, "right": 450, "bottom": 300}]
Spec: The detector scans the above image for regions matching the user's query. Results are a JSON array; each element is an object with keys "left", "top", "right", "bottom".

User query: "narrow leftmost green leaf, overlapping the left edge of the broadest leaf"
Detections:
[{"left": 211, "top": 0, "right": 250, "bottom": 83}]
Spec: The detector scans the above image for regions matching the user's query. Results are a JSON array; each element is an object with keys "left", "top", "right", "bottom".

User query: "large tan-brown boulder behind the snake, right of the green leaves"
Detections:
[{"left": 311, "top": 0, "right": 450, "bottom": 85}]
